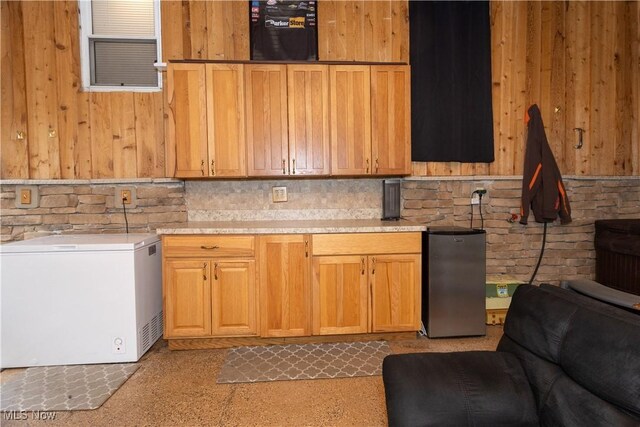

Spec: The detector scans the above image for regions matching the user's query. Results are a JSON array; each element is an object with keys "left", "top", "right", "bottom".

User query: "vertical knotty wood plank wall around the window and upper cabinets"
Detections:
[{"left": 0, "top": 0, "right": 640, "bottom": 179}]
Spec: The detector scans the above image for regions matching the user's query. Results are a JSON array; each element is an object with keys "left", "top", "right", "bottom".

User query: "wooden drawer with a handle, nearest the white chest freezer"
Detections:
[{"left": 162, "top": 235, "right": 255, "bottom": 257}]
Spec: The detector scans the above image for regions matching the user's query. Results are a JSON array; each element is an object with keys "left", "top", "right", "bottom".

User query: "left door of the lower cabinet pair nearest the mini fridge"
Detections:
[{"left": 313, "top": 256, "right": 368, "bottom": 335}]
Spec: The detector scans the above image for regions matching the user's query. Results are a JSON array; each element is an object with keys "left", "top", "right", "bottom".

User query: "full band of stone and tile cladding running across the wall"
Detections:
[{"left": 0, "top": 176, "right": 640, "bottom": 290}]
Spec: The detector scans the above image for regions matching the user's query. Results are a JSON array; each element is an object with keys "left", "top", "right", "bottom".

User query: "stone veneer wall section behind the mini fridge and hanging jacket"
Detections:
[{"left": 402, "top": 176, "right": 640, "bottom": 284}]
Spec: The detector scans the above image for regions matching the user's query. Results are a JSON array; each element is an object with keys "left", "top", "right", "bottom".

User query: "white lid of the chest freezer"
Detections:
[{"left": 0, "top": 234, "right": 160, "bottom": 253}]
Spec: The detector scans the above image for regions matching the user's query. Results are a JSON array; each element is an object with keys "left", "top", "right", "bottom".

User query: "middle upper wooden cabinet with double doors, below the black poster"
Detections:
[{"left": 245, "top": 64, "right": 330, "bottom": 176}]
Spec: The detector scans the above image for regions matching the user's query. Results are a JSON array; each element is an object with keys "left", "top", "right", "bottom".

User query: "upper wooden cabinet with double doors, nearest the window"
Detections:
[{"left": 168, "top": 63, "right": 246, "bottom": 178}]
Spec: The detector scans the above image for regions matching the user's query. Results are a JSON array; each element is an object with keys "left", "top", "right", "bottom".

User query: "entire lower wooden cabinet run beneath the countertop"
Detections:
[{"left": 163, "top": 232, "right": 422, "bottom": 343}]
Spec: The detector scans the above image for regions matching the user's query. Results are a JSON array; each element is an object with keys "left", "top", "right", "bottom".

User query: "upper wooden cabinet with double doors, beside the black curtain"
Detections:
[{"left": 330, "top": 65, "right": 411, "bottom": 175}]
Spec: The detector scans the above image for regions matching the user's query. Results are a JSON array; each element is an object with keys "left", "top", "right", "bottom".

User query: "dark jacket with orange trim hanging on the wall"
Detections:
[{"left": 520, "top": 104, "right": 571, "bottom": 224}]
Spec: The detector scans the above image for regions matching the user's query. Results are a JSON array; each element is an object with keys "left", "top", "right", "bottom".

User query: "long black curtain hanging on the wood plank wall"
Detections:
[{"left": 409, "top": 1, "right": 494, "bottom": 163}]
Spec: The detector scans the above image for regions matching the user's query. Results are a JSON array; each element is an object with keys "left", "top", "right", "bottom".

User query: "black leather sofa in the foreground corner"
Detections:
[{"left": 383, "top": 285, "right": 640, "bottom": 427}]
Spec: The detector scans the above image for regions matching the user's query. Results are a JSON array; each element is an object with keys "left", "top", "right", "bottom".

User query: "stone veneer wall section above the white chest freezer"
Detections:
[{"left": 0, "top": 179, "right": 187, "bottom": 242}]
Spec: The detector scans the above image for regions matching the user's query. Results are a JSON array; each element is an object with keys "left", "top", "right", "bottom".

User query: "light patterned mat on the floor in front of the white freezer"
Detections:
[{"left": 0, "top": 363, "right": 138, "bottom": 411}]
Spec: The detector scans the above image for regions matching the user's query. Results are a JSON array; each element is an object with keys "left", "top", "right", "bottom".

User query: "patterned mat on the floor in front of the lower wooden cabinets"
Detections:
[{"left": 217, "top": 341, "right": 391, "bottom": 383}]
